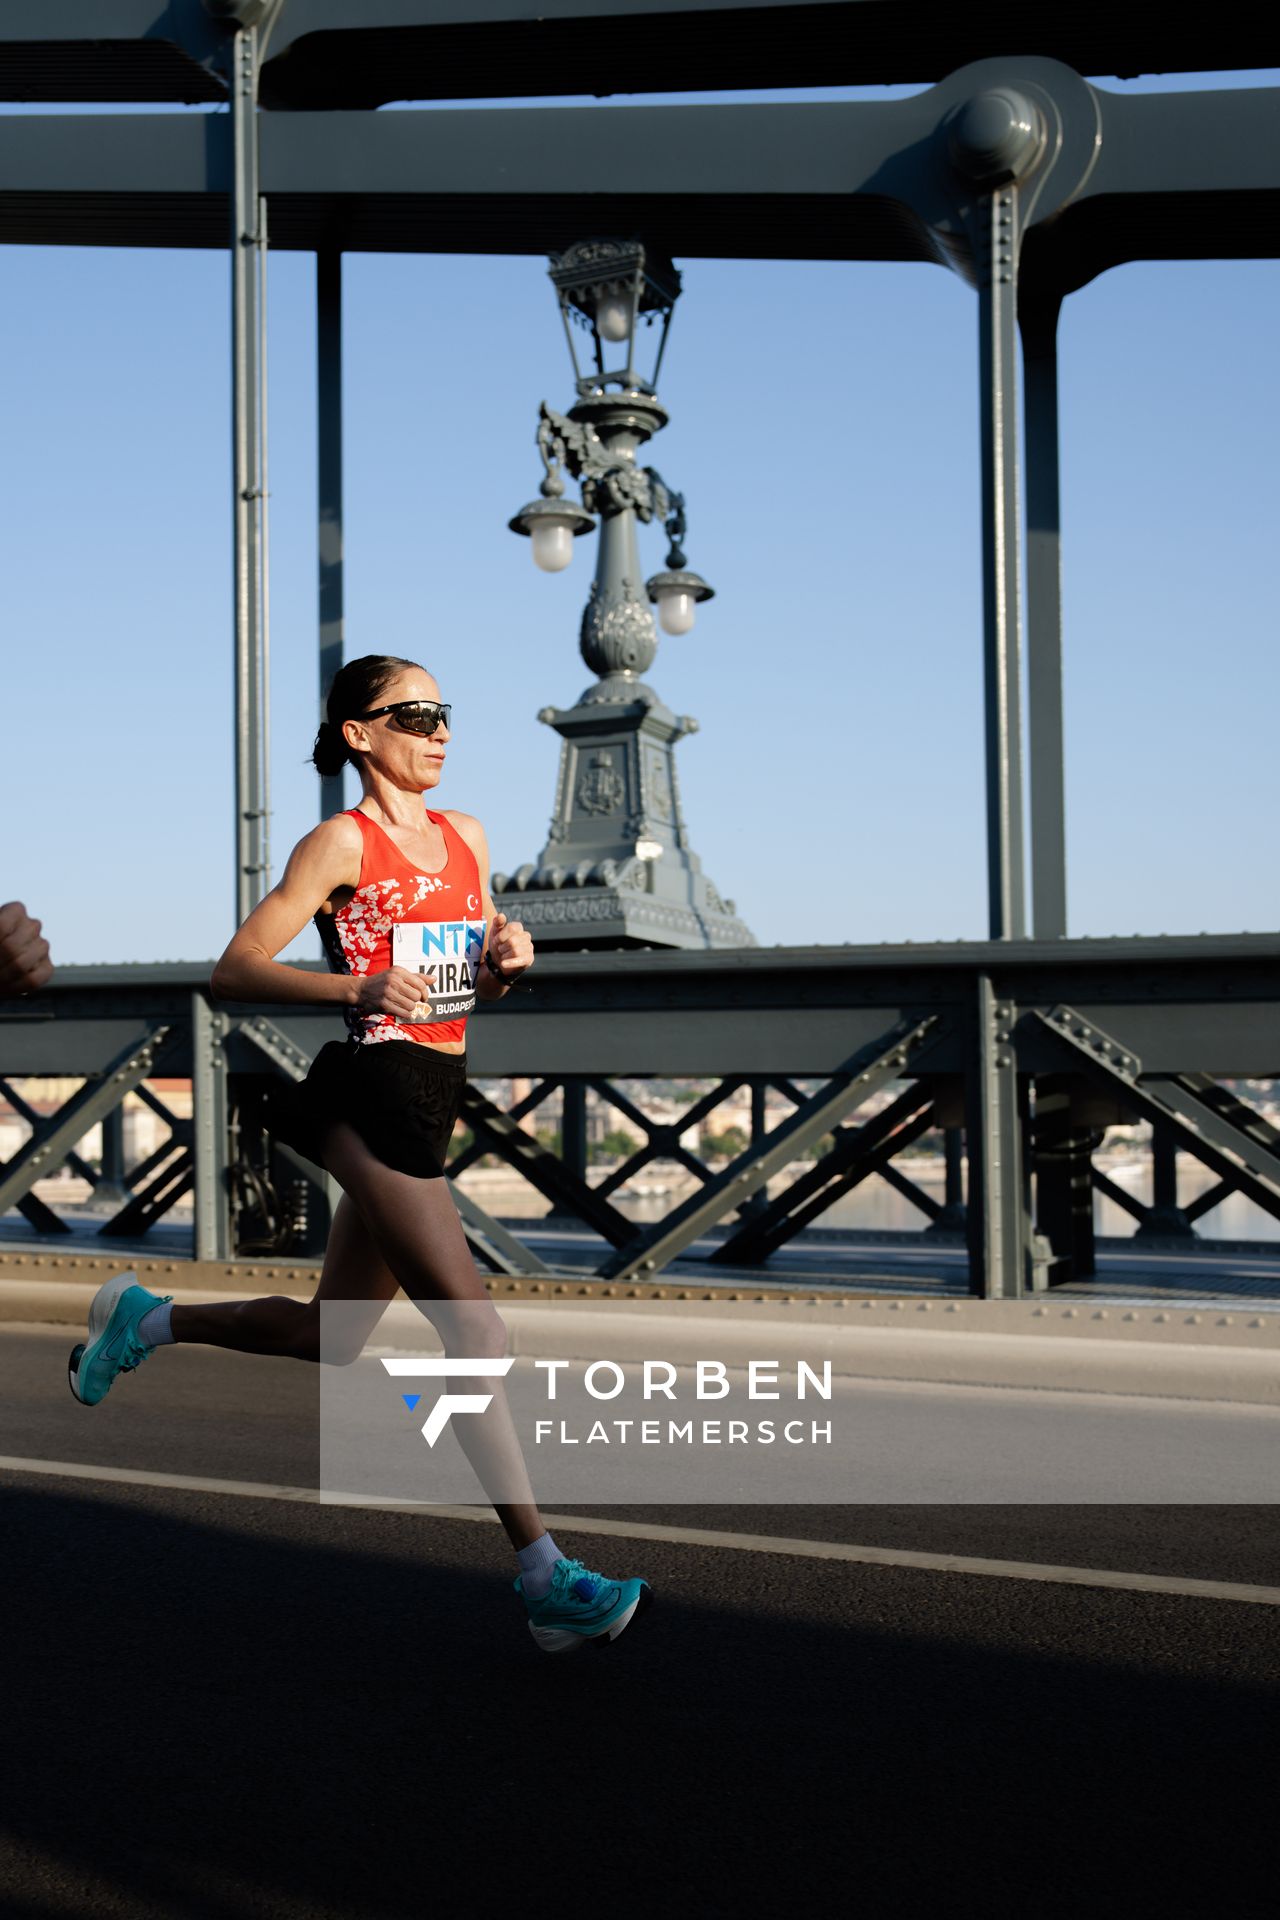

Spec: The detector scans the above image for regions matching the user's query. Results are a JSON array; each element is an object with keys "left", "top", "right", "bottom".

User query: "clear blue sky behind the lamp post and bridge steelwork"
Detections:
[{"left": 0, "top": 73, "right": 1280, "bottom": 962}]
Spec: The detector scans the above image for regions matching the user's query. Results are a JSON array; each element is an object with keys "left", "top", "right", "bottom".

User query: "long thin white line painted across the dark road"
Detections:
[{"left": 0, "top": 1453, "right": 1280, "bottom": 1607}]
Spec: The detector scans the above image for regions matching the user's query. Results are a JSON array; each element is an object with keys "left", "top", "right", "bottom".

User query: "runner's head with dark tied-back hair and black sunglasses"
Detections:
[{"left": 311, "top": 653, "right": 449, "bottom": 791}]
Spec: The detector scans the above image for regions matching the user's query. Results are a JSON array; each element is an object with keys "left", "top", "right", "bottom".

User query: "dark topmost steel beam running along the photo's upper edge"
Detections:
[{"left": 0, "top": 0, "right": 1280, "bottom": 109}]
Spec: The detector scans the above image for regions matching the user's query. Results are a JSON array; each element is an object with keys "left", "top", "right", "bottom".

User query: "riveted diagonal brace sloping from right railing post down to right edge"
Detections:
[{"left": 1036, "top": 1006, "right": 1280, "bottom": 1219}]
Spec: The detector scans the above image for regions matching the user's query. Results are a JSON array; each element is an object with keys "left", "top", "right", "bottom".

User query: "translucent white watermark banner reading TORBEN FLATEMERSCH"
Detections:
[{"left": 312, "top": 1302, "right": 1280, "bottom": 1505}]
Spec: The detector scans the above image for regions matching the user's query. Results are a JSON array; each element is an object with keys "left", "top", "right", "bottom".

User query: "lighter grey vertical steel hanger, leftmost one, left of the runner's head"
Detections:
[{"left": 228, "top": 29, "right": 271, "bottom": 925}]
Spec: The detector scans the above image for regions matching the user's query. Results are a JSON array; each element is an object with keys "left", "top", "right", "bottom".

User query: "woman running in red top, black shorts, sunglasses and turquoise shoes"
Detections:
[{"left": 69, "top": 655, "right": 651, "bottom": 1653}]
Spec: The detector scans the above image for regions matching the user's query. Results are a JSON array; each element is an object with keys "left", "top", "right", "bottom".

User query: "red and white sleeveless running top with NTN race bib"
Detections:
[{"left": 315, "top": 806, "right": 484, "bottom": 1044}]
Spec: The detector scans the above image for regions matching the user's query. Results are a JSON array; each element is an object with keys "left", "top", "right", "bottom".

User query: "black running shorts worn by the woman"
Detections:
[{"left": 265, "top": 1041, "right": 466, "bottom": 1181}]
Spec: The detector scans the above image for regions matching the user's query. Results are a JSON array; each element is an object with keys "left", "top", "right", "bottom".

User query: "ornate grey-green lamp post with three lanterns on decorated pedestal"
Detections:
[{"left": 493, "top": 240, "right": 754, "bottom": 947}]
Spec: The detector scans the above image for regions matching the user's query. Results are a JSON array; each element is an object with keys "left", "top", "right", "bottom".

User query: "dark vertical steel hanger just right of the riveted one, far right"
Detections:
[{"left": 1019, "top": 298, "right": 1067, "bottom": 941}]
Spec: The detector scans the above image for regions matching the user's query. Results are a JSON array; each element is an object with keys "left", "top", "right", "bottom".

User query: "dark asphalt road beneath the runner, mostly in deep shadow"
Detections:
[{"left": 0, "top": 1331, "right": 1280, "bottom": 1920}]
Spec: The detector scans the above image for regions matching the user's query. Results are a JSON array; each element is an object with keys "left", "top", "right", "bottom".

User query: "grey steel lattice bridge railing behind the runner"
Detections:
[{"left": 0, "top": 935, "right": 1280, "bottom": 1298}]
